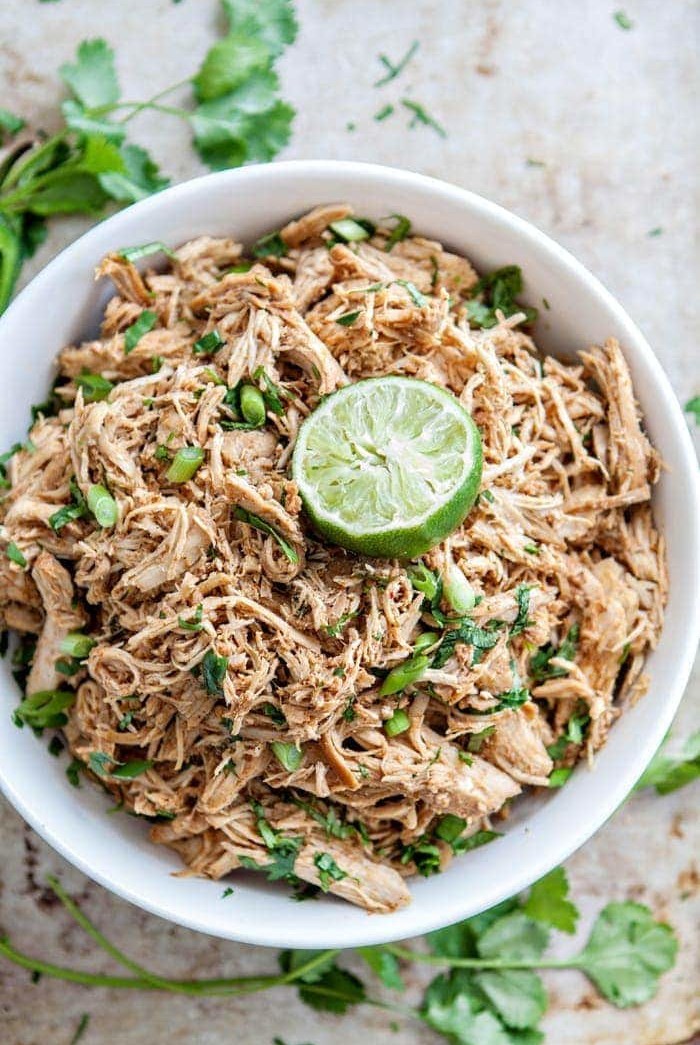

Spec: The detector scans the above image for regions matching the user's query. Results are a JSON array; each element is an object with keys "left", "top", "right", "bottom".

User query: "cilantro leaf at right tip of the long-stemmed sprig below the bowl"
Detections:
[{"left": 576, "top": 902, "right": 678, "bottom": 1008}]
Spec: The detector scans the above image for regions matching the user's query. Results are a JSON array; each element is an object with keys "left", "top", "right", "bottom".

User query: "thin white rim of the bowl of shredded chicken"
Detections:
[{"left": 0, "top": 160, "right": 700, "bottom": 948}]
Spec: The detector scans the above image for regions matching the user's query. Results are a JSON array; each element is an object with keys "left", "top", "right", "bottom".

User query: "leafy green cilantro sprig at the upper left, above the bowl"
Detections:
[{"left": 0, "top": 0, "right": 298, "bottom": 312}]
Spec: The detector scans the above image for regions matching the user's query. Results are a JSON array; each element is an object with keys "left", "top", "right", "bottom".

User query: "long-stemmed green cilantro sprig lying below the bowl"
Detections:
[{"left": 0, "top": 865, "right": 678, "bottom": 1045}]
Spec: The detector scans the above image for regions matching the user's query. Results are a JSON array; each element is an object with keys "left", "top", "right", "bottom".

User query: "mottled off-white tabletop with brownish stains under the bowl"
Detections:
[{"left": 0, "top": 0, "right": 700, "bottom": 1045}]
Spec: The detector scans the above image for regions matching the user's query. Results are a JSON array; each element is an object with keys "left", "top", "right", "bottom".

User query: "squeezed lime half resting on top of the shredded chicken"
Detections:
[{"left": 291, "top": 377, "right": 482, "bottom": 559}]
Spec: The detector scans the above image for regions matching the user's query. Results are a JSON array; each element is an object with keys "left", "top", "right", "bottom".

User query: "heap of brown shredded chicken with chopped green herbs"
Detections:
[{"left": 0, "top": 204, "right": 667, "bottom": 911}]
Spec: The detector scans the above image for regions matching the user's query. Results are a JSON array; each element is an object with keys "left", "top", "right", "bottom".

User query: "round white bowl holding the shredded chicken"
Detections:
[{"left": 0, "top": 161, "right": 700, "bottom": 948}]
